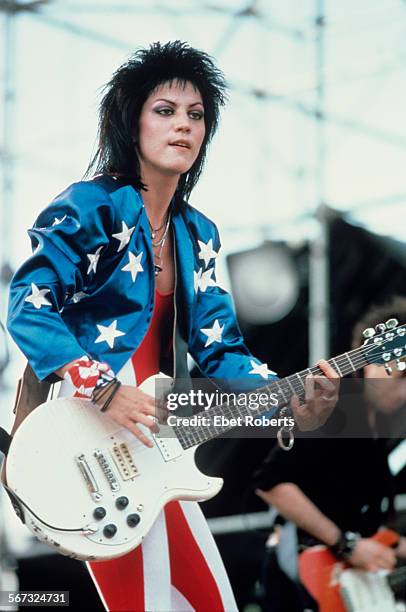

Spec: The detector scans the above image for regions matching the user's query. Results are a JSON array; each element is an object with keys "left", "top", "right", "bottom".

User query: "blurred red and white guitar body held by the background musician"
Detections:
[{"left": 299, "top": 529, "right": 399, "bottom": 612}]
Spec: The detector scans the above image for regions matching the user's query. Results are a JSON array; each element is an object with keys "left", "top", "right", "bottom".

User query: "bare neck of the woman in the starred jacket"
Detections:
[{"left": 142, "top": 167, "right": 179, "bottom": 227}]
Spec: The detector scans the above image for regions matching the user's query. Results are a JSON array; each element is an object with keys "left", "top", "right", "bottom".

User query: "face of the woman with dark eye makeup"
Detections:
[{"left": 137, "top": 81, "right": 205, "bottom": 178}]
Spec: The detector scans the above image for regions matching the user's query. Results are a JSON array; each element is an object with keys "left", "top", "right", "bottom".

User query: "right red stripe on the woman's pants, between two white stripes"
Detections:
[{"left": 165, "top": 502, "right": 224, "bottom": 612}]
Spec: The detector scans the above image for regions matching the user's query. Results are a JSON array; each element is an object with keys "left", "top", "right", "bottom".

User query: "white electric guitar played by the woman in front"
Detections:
[{"left": 6, "top": 319, "right": 406, "bottom": 561}]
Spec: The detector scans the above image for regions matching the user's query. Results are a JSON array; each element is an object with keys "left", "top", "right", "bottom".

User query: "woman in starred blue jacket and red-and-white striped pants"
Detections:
[{"left": 9, "top": 41, "right": 337, "bottom": 611}]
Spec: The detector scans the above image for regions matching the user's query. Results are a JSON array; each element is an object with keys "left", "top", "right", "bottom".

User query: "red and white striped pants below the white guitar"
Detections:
[{"left": 86, "top": 501, "right": 237, "bottom": 612}]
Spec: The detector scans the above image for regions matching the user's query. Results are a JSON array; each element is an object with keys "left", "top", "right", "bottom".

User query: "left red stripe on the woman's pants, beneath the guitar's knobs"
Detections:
[{"left": 89, "top": 546, "right": 145, "bottom": 612}]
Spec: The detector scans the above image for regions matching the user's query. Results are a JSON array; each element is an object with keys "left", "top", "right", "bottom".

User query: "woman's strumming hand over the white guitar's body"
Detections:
[{"left": 99, "top": 385, "right": 159, "bottom": 448}]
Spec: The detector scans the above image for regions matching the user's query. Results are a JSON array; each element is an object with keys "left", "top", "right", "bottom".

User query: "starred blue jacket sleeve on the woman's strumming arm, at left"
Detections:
[{"left": 7, "top": 182, "right": 113, "bottom": 381}]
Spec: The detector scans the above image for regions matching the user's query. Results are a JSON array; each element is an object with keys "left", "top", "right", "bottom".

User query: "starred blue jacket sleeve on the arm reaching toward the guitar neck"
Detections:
[{"left": 189, "top": 223, "right": 277, "bottom": 391}]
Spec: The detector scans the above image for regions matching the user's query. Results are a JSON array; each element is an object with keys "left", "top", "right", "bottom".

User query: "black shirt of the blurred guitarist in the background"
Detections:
[{"left": 254, "top": 394, "right": 394, "bottom": 536}]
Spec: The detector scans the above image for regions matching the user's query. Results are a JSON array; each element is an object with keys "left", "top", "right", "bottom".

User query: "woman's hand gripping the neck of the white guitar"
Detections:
[{"left": 291, "top": 359, "right": 340, "bottom": 431}]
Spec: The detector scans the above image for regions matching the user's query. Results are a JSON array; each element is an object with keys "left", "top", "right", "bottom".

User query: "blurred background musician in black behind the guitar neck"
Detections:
[{"left": 254, "top": 297, "right": 406, "bottom": 612}]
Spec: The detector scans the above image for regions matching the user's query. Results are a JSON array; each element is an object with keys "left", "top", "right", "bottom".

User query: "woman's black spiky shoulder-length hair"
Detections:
[{"left": 85, "top": 40, "right": 227, "bottom": 205}]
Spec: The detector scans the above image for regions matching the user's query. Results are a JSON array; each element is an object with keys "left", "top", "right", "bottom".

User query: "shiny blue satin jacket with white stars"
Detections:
[{"left": 8, "top": 176, "right": 274, "bottom": 386}]
